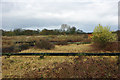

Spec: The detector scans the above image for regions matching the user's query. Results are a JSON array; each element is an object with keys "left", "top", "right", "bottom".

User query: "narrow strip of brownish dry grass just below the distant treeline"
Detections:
[{"left": 2, "top": 34, "right": 84, "bottom": 41}]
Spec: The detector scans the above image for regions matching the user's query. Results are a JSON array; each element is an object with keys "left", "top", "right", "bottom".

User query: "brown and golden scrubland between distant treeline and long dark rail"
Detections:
[{"left": 2, "top": 34, "right": 120, "bottom": 53}]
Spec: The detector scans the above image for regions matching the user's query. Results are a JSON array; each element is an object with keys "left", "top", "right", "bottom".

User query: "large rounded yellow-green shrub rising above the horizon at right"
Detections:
[{"left": 92, "top": 24, "right": 116, "bottom": 48}]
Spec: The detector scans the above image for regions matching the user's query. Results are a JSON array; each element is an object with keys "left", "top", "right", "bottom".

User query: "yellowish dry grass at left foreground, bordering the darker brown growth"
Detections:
[{"left": 2, "top": 56, "right": 75, "bottom": 77}]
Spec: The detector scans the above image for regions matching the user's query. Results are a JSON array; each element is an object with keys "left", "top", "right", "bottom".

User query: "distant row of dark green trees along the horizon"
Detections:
[{"left": 1, "top": 25, "right": 85, "bottom": 36}]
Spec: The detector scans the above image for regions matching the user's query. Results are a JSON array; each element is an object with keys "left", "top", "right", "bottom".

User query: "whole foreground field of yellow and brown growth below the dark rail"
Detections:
[{"left": 2, "top": 56, "right": 118, "bottom": 78}]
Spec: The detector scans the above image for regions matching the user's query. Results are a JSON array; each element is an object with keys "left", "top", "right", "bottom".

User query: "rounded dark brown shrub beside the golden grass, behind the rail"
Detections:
[{"left": 35, "top": 39, "right": 55, "bottom": 50}]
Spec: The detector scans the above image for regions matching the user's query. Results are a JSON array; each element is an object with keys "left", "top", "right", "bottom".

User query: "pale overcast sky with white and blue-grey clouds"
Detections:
[{"left": 0, "top": 0, "right": 119, "bottom": 32}]
